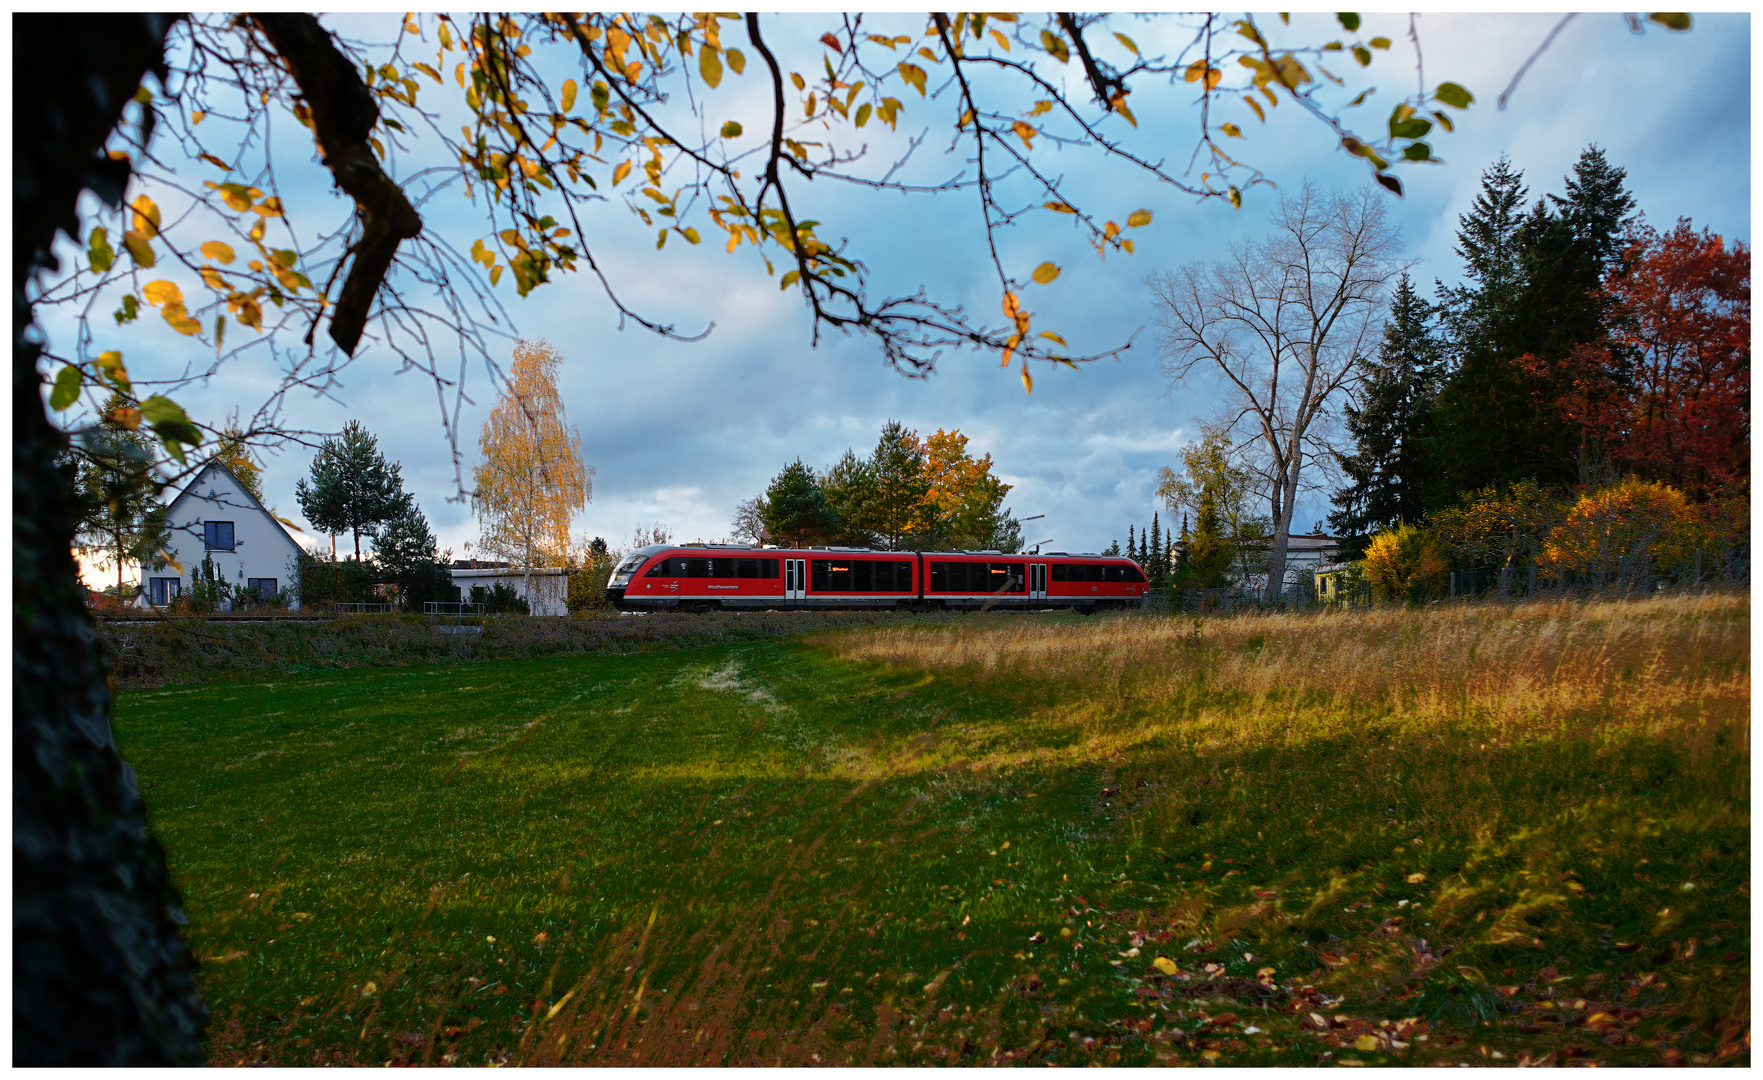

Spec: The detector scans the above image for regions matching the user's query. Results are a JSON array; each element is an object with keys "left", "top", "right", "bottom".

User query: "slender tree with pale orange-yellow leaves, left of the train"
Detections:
[{"left": 471, "top": 340, "right": 594, "bottom": 571}]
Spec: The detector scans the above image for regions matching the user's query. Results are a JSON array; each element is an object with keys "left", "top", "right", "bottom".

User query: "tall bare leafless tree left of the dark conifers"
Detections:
[{"left": 1149, "top": 183, "right": 1403, "bottom": 602}]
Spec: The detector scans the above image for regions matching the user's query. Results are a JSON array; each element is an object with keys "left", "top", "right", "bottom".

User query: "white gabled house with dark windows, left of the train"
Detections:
[{"left": 141, "top": 462, "right": 300, "bottom": 606}]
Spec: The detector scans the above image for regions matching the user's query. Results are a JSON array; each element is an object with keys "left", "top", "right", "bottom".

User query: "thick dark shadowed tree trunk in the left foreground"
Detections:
[{"left": 12, "top": 14, "right": 208, "bottom": 1066}]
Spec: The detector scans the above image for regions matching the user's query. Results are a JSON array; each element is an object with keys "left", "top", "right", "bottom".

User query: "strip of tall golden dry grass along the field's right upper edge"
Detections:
[{"left": 820, "top": 595, "right": 1751, "bottom": 749}]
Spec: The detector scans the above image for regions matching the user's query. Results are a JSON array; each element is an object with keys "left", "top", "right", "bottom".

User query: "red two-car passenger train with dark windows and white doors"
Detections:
[{"left": 606, "top": 544, "right": 1149, "bottom": 613}]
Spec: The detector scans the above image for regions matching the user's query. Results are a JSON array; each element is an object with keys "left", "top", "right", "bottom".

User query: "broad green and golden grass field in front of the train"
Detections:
[{"left": 116, "top": 599, "right": 1751, "bottom": 1064}]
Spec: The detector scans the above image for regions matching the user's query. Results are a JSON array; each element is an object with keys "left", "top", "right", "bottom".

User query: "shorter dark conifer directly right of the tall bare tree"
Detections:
[{"left": 1329, "top": 275, "right": 1444, "bottom": 558}]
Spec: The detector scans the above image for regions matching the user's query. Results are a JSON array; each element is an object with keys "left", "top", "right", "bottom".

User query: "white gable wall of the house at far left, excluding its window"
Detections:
[{"left": 141, "top": 465, "right": 310, "bottom": 603}]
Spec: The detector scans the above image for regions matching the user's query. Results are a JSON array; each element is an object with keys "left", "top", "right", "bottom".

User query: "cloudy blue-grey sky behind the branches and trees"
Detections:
[{"left": 44, "top": 14, "right": 1751, "bottom": 567}]
